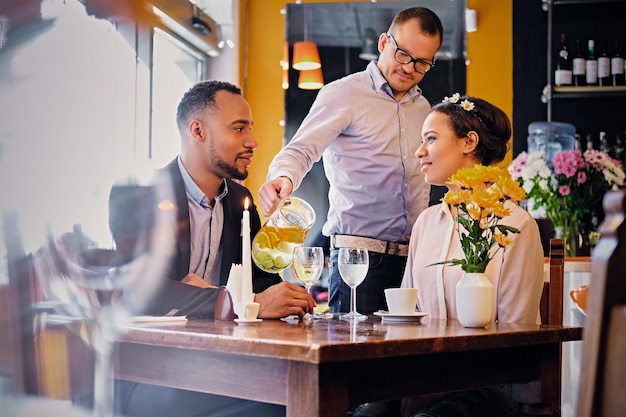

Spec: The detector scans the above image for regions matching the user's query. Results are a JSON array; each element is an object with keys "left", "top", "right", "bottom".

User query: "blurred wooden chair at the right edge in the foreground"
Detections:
[{"left": 577, "top": 189, "right": 626, "bottom": 417}]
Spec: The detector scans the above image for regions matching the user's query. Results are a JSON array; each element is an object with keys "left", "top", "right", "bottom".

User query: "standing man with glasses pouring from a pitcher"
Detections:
[{"left": 259, "top": 7, "right": 443, "bottom": 314}]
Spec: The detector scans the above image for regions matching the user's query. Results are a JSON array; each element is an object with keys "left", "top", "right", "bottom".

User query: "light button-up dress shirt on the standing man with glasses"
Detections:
[{"left": 267, "top": 61, "right": 430, "bottom": 242}]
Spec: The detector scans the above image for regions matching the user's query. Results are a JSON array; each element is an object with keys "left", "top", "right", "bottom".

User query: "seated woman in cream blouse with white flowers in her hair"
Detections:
[{"left": 355, "top": 94, "right": 543, "bottom": 417}]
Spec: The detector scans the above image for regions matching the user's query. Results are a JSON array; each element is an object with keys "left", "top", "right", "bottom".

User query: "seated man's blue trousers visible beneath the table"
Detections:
[{"left": 115, "top": 380, "right": 285, "bottom": 417}]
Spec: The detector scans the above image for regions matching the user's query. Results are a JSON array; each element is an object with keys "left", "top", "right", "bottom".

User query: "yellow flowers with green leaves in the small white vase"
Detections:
[{"left": 433, "top": 165, "right": 526, "bottom": 273}]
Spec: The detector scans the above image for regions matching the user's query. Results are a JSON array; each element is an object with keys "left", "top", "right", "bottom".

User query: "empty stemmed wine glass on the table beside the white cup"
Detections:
[{"left": 339, "top": 248, "right": 370, "bottom": 320}]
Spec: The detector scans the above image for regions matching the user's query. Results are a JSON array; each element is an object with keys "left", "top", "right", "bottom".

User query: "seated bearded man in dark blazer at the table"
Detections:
[{"left": 110, "top": 81, "right": 315, "bottom": 417}]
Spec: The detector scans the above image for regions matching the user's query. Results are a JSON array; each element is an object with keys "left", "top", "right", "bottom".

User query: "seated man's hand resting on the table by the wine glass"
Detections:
[{"left": 254, "top": 281, "right": 315, "bottom": 319}]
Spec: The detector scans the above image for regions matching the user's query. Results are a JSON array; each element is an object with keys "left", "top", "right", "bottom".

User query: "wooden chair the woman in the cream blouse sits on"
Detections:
[{"left": 513, "top": 238, "right": 565, "bottom": 416}]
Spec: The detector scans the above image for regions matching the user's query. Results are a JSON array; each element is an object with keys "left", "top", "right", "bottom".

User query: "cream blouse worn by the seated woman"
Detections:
[{"left": 402, "top": 202, "right": 543, "bottom": 323}]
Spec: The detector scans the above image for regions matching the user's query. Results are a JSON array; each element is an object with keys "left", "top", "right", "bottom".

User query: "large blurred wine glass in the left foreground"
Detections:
[{"left": 33, "top": 167, "right": 176, "bottom": 417}]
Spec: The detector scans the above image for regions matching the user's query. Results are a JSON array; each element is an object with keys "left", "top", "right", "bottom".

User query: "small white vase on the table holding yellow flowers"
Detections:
[{"left": 456, "top": 272, "right": 493, "bottom": 327}]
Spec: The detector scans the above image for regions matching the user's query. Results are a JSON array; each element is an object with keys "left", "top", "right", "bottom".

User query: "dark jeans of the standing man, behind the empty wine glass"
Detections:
[{"left": 328, "top": 248, "right": 406, "bottom": 314}]
